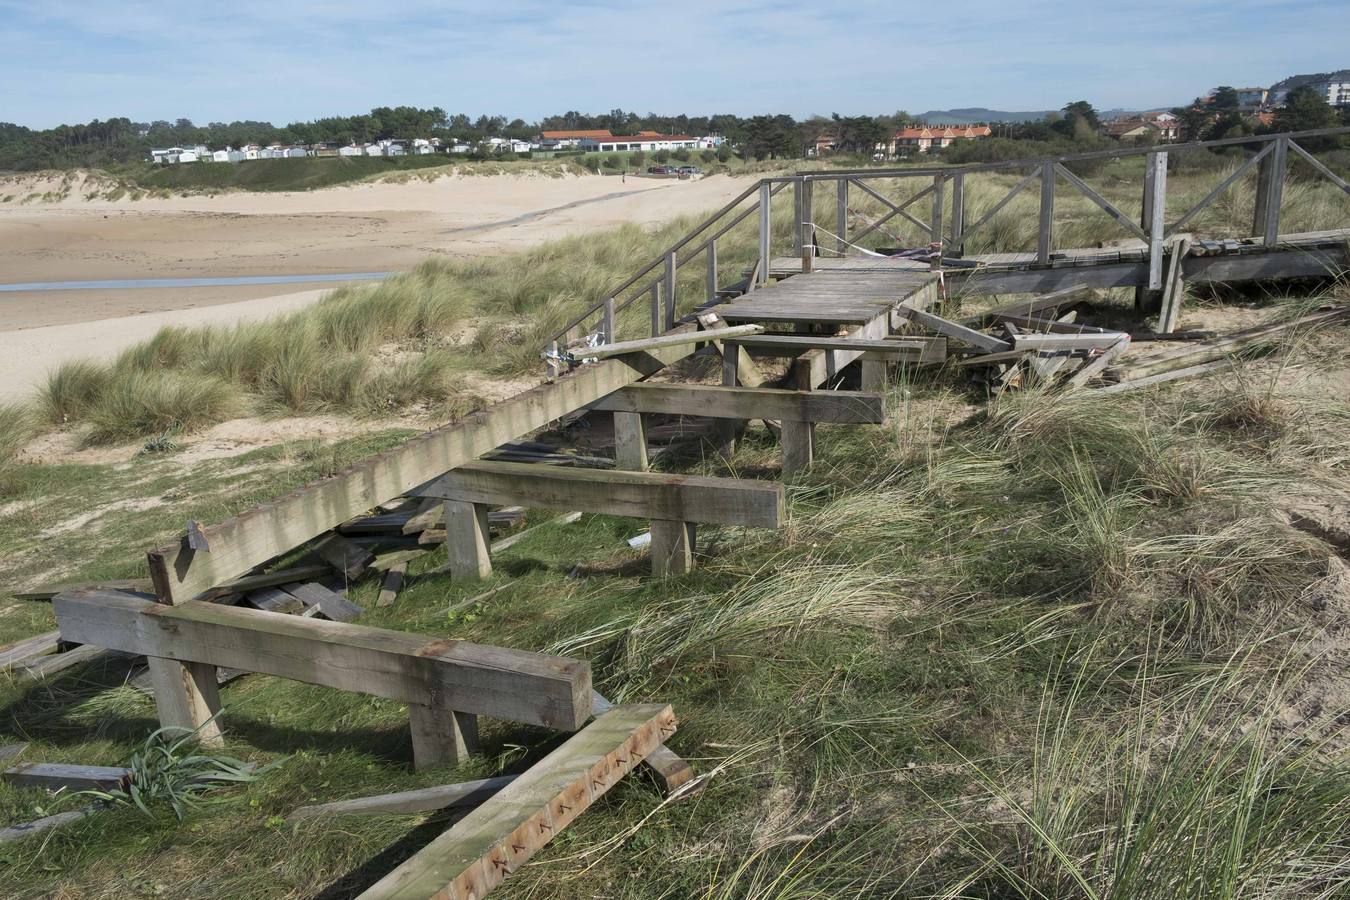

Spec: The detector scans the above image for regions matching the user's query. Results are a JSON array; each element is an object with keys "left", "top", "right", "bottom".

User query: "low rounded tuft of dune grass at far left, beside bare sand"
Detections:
[{"left": 86, "top": 371, "right": 238, "bottom": 444}]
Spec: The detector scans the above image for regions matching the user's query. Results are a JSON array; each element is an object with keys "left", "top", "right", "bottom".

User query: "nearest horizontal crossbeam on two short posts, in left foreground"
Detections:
[{"left": 51, "top": 591, "right": 591, "bottom": 731}]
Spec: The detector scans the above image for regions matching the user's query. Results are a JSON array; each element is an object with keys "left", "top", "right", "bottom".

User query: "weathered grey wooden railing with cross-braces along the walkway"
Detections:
[{"left": 549, "top": 128, "right": 1350, "bottom": 354}]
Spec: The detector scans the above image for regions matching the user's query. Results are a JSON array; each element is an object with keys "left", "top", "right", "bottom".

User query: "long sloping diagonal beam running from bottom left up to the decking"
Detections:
[{"left": 150, "top": 325, "right": 706, "bottom": 603}]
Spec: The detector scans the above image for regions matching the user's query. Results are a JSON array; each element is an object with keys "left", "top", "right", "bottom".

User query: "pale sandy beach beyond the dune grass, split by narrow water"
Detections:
[{"left": 0, "top": 175, "right": 748, "bottom": 401}]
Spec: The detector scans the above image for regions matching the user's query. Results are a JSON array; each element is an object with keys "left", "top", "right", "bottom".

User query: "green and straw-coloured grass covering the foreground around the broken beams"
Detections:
[{"left": 0, "top": 301, "right": 1350, "bottom": 900}]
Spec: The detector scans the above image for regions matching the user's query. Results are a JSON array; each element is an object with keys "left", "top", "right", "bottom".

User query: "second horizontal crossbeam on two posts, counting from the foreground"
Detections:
[{"left": 416, "top": 463, "right": 786, "bottom": 528}]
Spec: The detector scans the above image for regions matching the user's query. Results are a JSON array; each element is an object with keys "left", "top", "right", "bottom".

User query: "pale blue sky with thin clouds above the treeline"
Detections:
[{"left": 0, "top": 0, "right": 1350, "bottom": 127}]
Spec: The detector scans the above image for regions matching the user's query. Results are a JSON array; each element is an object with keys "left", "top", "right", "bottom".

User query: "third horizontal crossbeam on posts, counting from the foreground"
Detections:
[{"left": 591, "top": 380, "right": 890, "bottom": 425}]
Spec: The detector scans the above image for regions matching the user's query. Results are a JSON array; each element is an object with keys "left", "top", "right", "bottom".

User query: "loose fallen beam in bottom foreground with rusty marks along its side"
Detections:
[{"left": 360, "top": 703, "right": 675, "bottom": 900}]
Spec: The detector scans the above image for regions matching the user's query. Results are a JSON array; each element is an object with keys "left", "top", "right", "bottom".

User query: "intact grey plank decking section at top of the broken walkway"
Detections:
[{"left": 718, "top": 269, "right": 937, "bottom": 325}]
